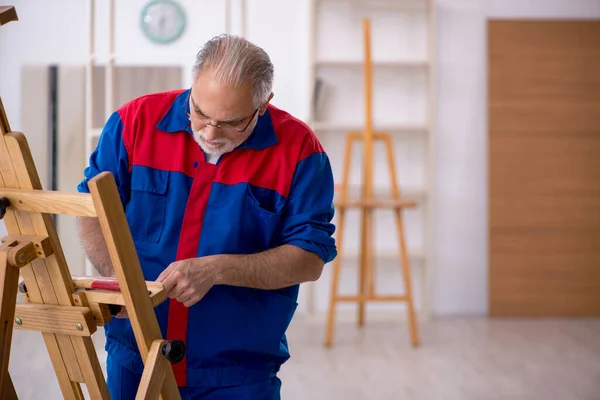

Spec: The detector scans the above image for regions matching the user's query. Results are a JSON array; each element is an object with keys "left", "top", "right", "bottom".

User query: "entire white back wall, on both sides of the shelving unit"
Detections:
[{"left": 0, "top": 0, "right": 600, "bottom": 314}]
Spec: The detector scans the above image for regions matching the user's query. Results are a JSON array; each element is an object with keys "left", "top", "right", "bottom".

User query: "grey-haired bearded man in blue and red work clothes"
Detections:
[{"left": 78, "top": 35, "right": 336, "bottom": 400}]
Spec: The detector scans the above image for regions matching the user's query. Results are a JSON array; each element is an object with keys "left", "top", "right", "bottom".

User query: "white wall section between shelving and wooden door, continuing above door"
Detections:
[{"left": 432, "top": 0, "right": 600, "bottom": 314}]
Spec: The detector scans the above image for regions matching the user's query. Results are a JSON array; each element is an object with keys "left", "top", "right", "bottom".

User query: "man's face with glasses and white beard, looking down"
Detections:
[{"left": 190, "top": 70, "right": 264, "bottom": 155}]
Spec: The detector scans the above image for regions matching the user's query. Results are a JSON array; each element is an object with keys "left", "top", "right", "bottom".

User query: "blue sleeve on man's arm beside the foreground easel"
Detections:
[{"left": 77, "top": 112, "right": 131, "bottom": 204}]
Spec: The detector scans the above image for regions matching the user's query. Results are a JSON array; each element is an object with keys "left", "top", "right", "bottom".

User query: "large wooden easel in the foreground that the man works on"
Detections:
[{"left": 0, "top": 6, "right": 185, "bottom": 400}]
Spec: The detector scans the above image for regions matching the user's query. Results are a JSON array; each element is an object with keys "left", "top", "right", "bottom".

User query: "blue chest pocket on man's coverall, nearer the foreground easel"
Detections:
[{"left": 125, "top": 166, "right": 169, "bottom": 243}]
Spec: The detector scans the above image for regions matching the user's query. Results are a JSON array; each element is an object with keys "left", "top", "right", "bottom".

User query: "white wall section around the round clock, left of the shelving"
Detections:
[{"left": 0, "top": 0, "right": 308, "bottom": 134}]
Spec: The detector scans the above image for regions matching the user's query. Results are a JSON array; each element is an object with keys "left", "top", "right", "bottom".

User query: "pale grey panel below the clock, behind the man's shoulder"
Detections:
[{"left": 92, "top": 66, "right": 182, "bottom": 129}]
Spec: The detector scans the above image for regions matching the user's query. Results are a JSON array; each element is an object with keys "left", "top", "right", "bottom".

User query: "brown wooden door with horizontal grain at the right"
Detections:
[{"left": 488, "top": 20, "right": 600, "bottom": 316}]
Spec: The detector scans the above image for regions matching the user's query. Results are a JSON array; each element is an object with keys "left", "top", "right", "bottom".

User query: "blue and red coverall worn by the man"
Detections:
[{"left": 78, "top": 89, "right": 337, "bottom": 399}]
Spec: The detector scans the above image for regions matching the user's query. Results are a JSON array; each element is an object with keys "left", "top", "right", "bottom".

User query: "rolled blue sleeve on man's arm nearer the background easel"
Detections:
[{"left": 282, "top": 152, "right": 337, "bottom": 263}]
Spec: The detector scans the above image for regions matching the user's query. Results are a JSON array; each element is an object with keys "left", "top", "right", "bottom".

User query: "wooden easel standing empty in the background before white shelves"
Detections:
[{"left": 325, "top": 19, "right": 419, "bottom": 347}]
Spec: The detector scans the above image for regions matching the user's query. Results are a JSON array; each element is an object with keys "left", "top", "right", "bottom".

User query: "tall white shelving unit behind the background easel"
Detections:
[{"left": 303, "top": 0, "right": 437, "bottom": 318}]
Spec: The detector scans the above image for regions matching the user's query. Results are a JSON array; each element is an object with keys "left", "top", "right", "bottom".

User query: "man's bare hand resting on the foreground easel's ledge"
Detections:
[{"left": 156, "top": 256, "right": 218, "bottom": 307}]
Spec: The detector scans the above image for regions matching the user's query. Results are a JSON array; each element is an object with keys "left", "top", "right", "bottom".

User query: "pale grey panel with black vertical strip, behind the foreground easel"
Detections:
[{"left": 21, "top": 65, "right": 86, "bottom": 275}]
